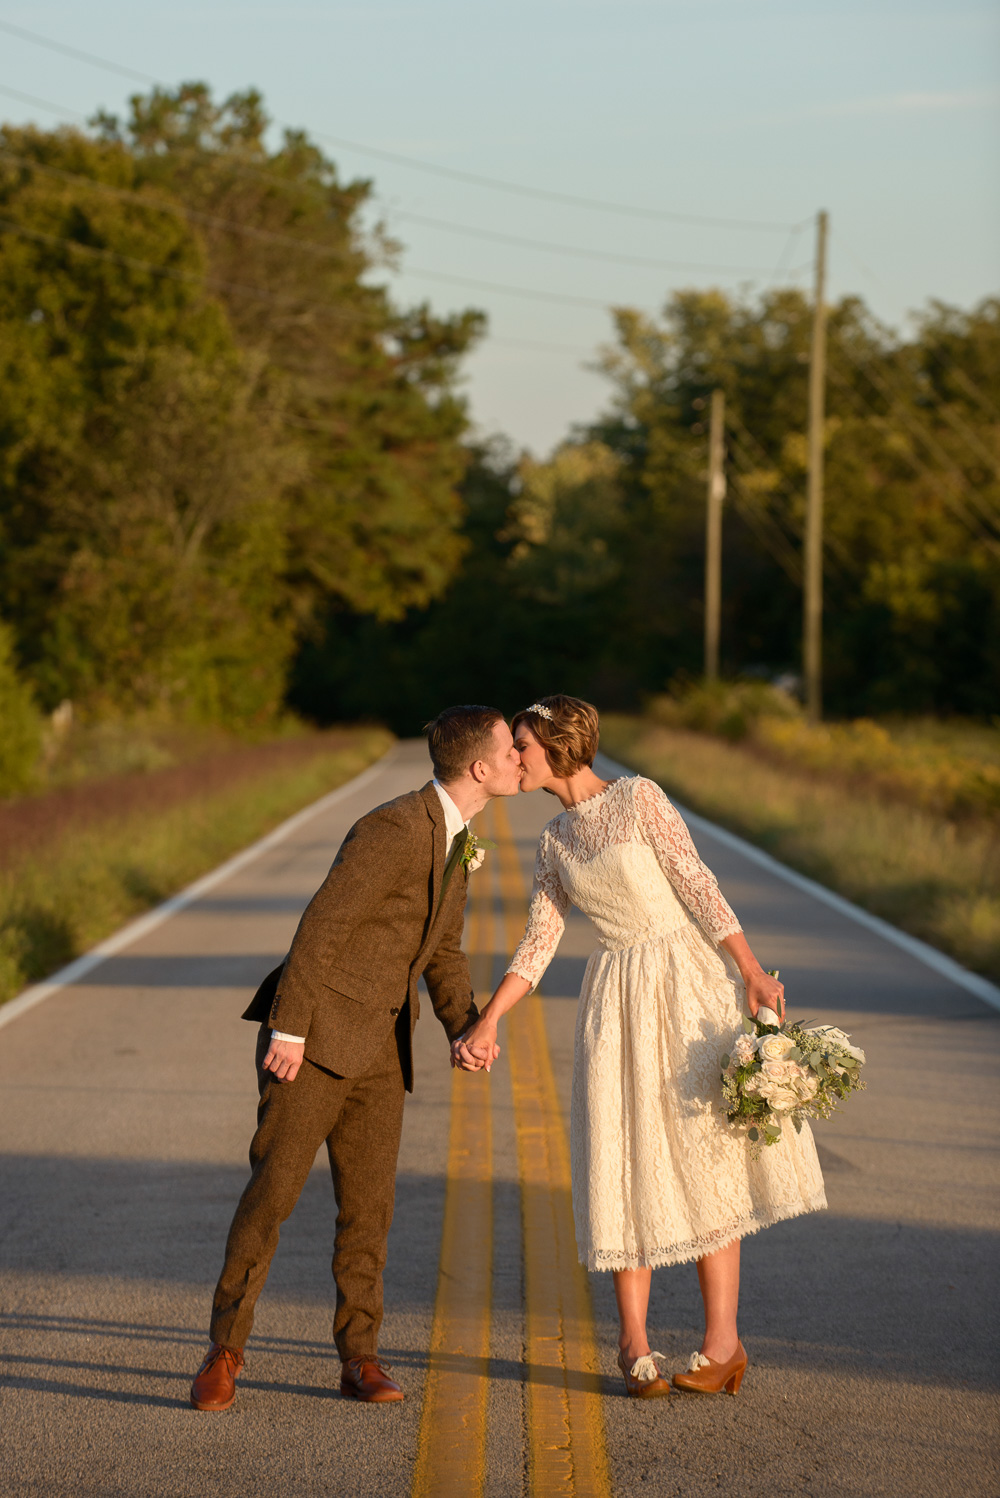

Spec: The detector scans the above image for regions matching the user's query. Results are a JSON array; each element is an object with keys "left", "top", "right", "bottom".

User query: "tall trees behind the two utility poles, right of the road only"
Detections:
[{"left": 593, "top": 291, "right": 1000, "bottom": 715}]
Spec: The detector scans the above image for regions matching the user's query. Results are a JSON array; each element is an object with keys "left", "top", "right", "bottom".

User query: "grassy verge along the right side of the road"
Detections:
[{"left": 602, "top": 716, "right": 1000, "bottom": 980}]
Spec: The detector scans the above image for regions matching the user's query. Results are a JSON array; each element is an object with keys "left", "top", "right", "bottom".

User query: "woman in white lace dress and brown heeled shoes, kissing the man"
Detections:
[{"left": 454, "top": 695, "right": 826, "bottom": 1399}]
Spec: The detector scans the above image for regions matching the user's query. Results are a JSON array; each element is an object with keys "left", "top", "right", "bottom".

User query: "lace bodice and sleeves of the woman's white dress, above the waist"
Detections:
[{"left": 507, "top": 774, "right": 743, "bottom": 986}]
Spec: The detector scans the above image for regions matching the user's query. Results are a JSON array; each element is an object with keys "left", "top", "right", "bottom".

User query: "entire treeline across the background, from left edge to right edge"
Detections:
[{"left": 0, "top": 84, "right": 1000, "bottom": 749}]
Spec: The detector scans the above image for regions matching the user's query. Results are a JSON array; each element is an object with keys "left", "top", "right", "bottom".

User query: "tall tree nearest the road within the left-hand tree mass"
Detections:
[{"left": 100, "top": 84, "right": 484, "bottom": 619}]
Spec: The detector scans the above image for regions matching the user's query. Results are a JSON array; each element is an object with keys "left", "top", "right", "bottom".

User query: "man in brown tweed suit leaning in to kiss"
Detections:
[{"left": 192, "top": 707, "right": 521, "bottom": 1410}]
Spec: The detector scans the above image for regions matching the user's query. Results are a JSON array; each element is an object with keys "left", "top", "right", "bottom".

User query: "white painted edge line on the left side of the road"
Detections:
[{"left": 0, "top": 745, "right": 395, "bottom": 1029}]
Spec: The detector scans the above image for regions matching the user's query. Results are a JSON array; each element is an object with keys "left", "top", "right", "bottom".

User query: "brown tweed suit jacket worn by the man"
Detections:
[{"left": 243, "top": 780, "right": 479, "bottom": 1092}]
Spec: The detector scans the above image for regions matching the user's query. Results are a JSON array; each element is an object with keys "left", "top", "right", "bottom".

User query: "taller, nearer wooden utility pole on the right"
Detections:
[{"left": 802, "top": 210, "right": 828, "bottom": 724}]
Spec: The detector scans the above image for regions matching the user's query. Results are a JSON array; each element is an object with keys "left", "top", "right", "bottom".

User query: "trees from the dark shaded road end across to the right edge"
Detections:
[{"left": 292, "top": 291, "right": 1000, "bottom": 739}]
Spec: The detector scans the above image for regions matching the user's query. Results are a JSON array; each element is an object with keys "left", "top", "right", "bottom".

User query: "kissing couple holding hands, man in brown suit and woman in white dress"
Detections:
[{"left": 192, "top": 694, "right": 826, "bottom": 1410}]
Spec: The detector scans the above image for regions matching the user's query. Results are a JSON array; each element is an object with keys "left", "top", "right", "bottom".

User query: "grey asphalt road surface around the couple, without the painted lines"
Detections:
[{"left": 0, "top": 745, "right": 1000, "bottom": 1498}]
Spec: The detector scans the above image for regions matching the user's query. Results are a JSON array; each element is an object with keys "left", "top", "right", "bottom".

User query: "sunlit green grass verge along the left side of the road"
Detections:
[{"left": 0, "top": 728, "right": 392, "bottom": 1002}]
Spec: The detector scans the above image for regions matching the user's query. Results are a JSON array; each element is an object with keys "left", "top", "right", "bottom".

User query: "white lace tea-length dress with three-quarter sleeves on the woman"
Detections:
[{"left": 507, "top": 776, "right": 826, "bottom": 1269}]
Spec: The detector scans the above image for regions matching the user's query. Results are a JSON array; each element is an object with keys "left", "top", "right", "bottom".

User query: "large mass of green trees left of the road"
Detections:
[{"left": 0, "top": 85, "right": 482, "bottom": 725}]
